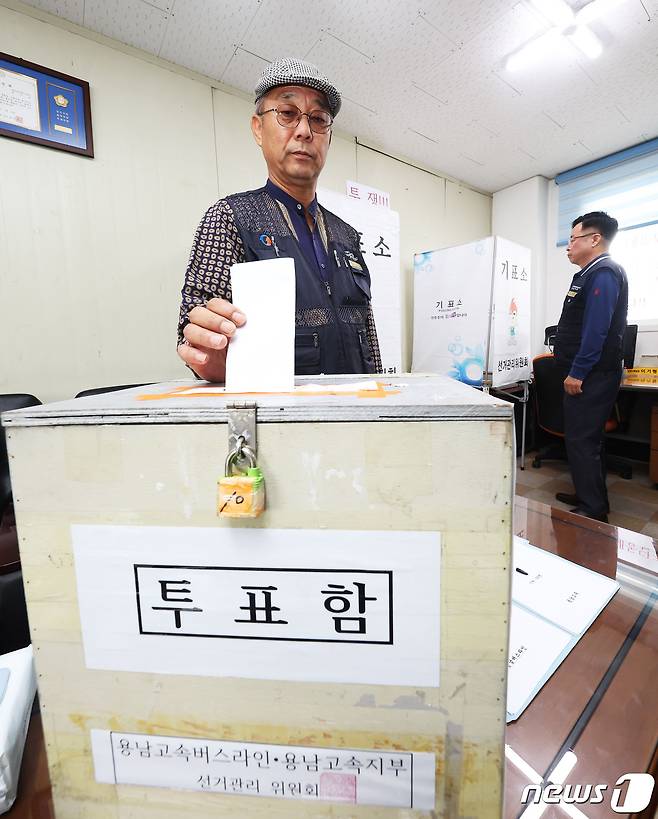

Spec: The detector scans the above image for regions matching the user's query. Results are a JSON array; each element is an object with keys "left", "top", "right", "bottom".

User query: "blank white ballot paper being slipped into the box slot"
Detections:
[{"left": 226, "top": 259, "right": 295, "bottom": 392}]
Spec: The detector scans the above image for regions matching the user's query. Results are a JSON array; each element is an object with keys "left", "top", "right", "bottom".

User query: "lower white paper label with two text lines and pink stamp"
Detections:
[{"left": 91, "top": 730, "right": 435, "bottom": 810}]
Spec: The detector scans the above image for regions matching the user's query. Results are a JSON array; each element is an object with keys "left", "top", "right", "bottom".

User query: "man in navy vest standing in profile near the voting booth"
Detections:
[{"left": 555, "top": 211, "right": 628, "bottom": 521}]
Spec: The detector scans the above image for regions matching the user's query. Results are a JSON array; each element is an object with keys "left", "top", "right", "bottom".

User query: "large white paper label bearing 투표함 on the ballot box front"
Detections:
[{"left": 72, "top": 525, "right": 441, "bottom": 687}]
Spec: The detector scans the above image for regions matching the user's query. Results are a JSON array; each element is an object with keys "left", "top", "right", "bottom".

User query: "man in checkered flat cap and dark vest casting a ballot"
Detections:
[{"left": 178, "top": 59, "right": 381, "bottom": 382}]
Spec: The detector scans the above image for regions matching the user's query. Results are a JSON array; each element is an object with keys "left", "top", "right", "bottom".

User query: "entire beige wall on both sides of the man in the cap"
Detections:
[{"left": 0, "top": 5, "right": 491, "bottom": 401}]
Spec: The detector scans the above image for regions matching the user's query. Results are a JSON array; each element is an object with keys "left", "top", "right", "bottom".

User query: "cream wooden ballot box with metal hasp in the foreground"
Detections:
[{"left": 3, "top": 375, "right": 514, "bottom": 819}]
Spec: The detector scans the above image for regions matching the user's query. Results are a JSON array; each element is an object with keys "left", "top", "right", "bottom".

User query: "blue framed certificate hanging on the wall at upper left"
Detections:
[{"left": 0, "top": 52, "right": 94, "bottom": 157}]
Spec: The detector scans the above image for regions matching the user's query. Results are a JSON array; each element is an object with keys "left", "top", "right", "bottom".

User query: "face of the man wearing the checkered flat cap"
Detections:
[{"left": 251, "top": 85, "right": 331, "bottom": 186}]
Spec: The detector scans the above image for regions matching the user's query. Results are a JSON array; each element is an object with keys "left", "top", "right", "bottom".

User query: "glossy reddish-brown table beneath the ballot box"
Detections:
[{"left": 9, "top": 497, "right": 658, "bottom": 819}]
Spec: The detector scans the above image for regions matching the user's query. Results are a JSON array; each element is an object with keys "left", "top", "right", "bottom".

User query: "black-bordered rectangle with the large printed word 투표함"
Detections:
[{"left": 135, "top": 565, "right": 393, "bottom": 644}]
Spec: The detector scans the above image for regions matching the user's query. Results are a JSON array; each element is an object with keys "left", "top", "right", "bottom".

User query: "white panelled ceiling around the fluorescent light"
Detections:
[{"left": 16, "top": 0, "right": 658, "bottom": 191}]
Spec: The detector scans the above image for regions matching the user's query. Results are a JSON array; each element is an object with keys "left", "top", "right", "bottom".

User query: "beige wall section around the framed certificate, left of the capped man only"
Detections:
[{"left": 0, "top": 7, "right": 217, "bottom": 401}]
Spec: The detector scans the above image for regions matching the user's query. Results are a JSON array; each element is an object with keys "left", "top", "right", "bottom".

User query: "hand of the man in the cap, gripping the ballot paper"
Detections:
[{"left": 178, "top": 299, "right": 247, "bottom": 381}]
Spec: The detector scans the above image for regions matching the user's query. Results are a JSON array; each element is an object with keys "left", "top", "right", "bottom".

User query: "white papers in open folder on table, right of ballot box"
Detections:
[{"left": 507, "top": 537, "right": 619, "bottom": 722}]
